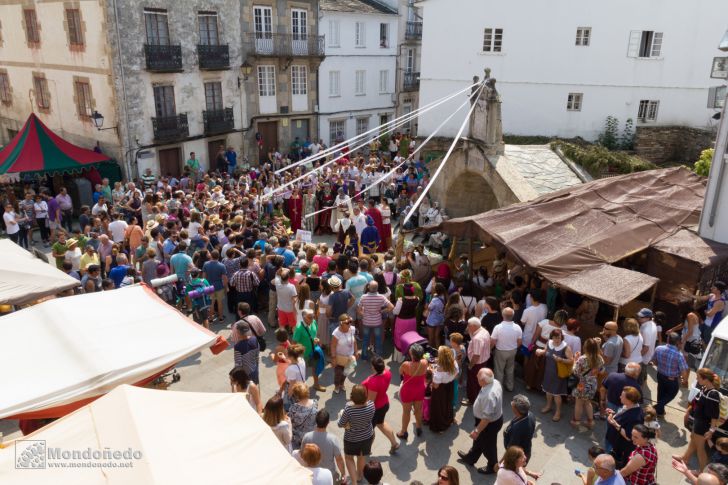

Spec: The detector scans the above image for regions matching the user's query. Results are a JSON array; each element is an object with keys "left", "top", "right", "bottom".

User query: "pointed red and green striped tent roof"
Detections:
[{"left": 0, "top": 113, "right": 111, "bottom": 175}]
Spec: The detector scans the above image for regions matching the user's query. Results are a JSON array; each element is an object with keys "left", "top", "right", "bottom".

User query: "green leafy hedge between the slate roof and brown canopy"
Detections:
[{"left": 551, "top": 141, "right": 658, "bottom": 178}]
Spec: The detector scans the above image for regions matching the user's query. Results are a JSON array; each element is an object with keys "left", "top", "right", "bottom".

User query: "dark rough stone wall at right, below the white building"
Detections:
[{"left": 634, "top": 126, "right": 715, "bottom": 165}]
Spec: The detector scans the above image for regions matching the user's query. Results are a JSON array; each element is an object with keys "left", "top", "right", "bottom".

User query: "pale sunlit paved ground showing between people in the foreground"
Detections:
[{"left": 0, "top": 233, "right": 688, "bottom": 485}]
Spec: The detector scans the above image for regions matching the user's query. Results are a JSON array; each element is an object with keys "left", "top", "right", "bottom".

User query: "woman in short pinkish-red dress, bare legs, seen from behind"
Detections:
[{"left": 397, "top": 344, "right": 427, "bottom": 441}]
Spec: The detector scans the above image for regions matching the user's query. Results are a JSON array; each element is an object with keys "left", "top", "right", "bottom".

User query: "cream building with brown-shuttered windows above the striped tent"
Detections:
[{"left": 0, "top": 0, "right": 123, "bottom": 160}]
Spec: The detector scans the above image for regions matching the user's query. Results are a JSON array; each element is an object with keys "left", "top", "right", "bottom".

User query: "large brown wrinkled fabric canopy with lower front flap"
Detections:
[{"left": 427, "top": 167, "right": 706, "bottom": 306}]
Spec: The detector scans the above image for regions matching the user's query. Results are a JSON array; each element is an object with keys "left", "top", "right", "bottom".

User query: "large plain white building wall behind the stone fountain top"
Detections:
[{"left": 417, "top": 0, "right": 728, "bottom": 140}]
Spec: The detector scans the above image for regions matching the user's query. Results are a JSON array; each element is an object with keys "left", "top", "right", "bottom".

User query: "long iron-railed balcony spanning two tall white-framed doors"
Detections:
[{"left": 245, "top": 32, "right": 324, "bottom": 58}]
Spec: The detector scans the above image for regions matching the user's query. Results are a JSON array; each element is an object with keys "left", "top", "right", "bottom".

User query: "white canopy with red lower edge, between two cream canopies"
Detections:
[{"left": 0, "top": 285, "right": 227, "bottom": 419}]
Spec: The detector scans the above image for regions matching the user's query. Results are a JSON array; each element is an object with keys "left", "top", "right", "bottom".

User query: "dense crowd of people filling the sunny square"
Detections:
[{"left": 3, "top": 132, "right": 728, "bottom": 485}]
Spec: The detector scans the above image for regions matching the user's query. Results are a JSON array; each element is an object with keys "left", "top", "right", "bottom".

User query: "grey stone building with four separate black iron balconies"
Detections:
[{"left": 103, "top": 0, "right": 247, "bottom": 176}]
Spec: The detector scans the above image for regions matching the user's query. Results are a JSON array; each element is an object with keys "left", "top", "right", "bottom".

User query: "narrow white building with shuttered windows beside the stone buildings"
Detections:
[{"left": 319, "top": 0, "right": 399, "bottom": 148}]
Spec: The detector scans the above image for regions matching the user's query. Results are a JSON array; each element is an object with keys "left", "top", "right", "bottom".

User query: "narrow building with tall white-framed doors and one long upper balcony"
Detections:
[{"left": 238, "top": 0, "right": 324, "bottom": 162}]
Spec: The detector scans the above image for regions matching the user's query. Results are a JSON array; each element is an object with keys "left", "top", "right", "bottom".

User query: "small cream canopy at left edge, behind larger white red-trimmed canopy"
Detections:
[{"left": 0, "top": 239, "right": 81, "bottom": 305}]
